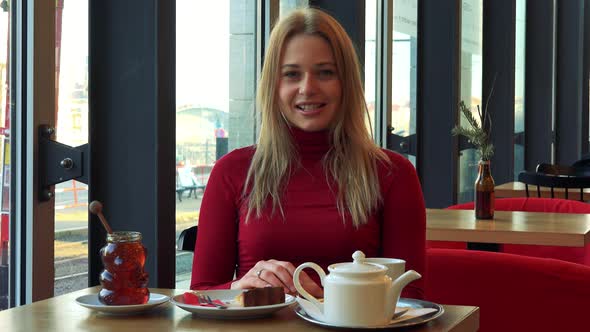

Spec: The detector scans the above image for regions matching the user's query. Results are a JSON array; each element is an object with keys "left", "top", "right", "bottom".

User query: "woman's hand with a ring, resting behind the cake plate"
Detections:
[{"left": 231, "top": 259, "right": 324, "bottom": 298}]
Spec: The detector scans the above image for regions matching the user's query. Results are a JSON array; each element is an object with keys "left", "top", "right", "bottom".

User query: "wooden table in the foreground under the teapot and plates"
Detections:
[{"left": 0, "top": 287, "right": 479, "bottom": 332}]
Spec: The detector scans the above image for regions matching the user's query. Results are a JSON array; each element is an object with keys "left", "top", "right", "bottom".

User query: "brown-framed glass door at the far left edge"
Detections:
[{"left": 0, "top": 0, "right": 63, "bottom": 308}]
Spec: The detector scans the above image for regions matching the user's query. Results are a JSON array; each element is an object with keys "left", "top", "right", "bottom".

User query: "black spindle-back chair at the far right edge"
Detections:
[{"left": 518, "top": 163, "right": 590, "bottom": 201}]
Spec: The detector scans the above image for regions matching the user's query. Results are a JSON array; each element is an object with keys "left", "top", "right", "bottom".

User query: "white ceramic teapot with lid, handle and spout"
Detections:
[{"left": 293, "top": 251, "right": 421, "bottom": 327}]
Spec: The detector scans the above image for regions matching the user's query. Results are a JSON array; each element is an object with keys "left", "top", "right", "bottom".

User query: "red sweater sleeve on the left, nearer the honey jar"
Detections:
[{"left": 190, "top": 149, "right": 251, "bottom": 289}]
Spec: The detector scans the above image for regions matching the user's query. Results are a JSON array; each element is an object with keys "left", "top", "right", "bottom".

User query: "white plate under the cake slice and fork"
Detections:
[{"left": 170, "top": 289, "right": 295, "bottom": 319}]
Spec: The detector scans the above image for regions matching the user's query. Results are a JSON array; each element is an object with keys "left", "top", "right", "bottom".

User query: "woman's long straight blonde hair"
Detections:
[{"left": 244, "top": 8, "right": 390, "bottom": 227}]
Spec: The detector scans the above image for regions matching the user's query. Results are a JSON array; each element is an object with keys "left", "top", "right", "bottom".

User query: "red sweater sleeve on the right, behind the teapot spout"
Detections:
[{"left": 381, "top": 152, "right": 426, "bottom": 299}]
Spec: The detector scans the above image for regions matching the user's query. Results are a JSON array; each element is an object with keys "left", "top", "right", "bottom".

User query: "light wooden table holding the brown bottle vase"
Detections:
[{"left": 426, "top": 209, "right": 590, "bottom": 247}]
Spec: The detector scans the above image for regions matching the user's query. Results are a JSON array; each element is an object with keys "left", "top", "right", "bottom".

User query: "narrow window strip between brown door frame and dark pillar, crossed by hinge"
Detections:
[{"left": 54, "top": 0, "right": 88, "bottom": 295}]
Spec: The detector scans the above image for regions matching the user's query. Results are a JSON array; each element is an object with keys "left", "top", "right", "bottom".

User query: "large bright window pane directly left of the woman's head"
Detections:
[{"left": 176, "top": 0, "right": 257, "bottom": 289}]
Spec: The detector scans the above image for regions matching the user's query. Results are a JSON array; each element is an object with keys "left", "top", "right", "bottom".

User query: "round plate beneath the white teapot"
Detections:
[{"left": 294, "top": 298, "right": 445, "bottom": 329}]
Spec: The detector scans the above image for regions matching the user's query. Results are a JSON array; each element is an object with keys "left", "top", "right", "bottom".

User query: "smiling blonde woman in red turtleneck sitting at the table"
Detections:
[{"left": 191, "top": 9, "right": 425, "bottom": 298}]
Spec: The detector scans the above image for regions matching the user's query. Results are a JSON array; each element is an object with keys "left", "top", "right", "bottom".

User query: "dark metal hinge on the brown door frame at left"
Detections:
[{"left": 39, "top": 125, "right": 88, "bottom": 202}]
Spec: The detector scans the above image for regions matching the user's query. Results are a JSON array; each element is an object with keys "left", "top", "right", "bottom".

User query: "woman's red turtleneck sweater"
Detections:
[{"left": 191, "top": 129, "right": 426, "bottom": 298}]
